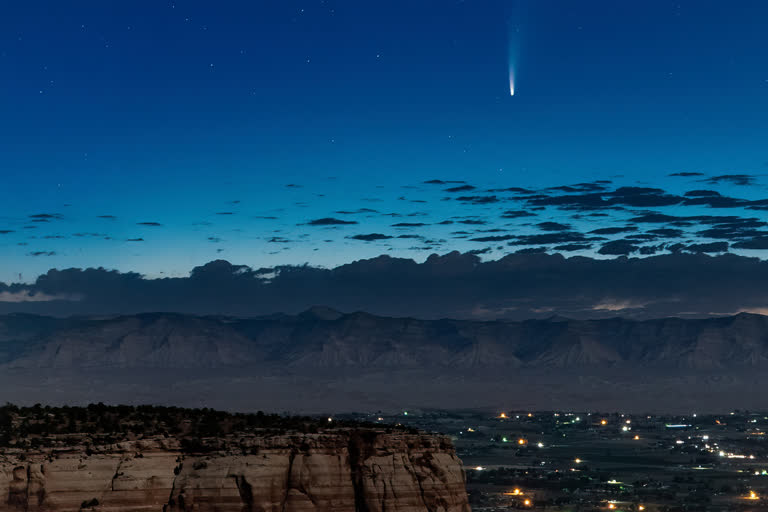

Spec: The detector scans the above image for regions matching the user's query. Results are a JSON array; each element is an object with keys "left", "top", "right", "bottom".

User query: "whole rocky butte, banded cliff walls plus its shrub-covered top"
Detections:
[{"left": 0, "top": 406, "right": 470, "bottom": 512}]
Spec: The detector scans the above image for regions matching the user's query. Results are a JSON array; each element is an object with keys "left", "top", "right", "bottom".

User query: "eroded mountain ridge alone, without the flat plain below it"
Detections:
[{"left": 0, "top": 306, "right": 768, "bottom": 372}]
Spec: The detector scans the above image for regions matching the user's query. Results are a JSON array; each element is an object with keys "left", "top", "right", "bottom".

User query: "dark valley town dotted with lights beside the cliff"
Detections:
[{"left": 340, "top": 411, "right": 768, "bottom": 512}]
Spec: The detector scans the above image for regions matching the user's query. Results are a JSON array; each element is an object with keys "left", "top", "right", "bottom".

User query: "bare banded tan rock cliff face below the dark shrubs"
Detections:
[{"left": 0, "top": 430, "right": 470, "bottom": 512}]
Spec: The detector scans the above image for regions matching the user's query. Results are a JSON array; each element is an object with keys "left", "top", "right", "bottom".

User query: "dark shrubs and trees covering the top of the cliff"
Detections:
[{"left": 0, "top": 403, "right": 407, "bottom": 451}]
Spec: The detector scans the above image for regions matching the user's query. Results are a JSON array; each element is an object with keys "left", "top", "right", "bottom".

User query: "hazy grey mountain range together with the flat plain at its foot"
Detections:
[{"left": 0, "top": 307, "right": 768, "bottom": 414}]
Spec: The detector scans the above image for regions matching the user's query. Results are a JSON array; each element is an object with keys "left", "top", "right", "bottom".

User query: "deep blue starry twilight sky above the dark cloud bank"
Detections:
[{"left": 0, "top": 0, "right": 768, "bottom": 281}]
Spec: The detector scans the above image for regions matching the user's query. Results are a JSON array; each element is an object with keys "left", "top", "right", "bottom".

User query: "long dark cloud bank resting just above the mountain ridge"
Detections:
[{"left": 0, "top": 252, "right": 768, "bottom": 319}]
